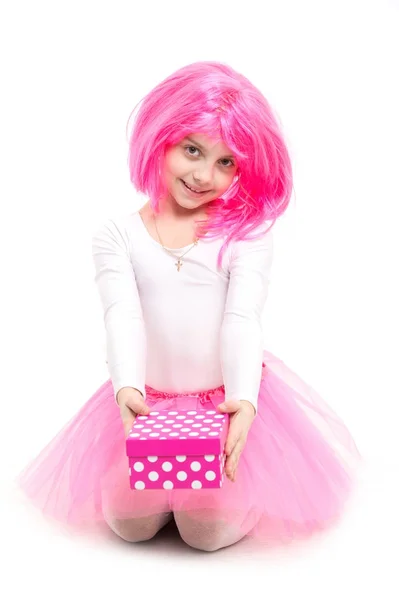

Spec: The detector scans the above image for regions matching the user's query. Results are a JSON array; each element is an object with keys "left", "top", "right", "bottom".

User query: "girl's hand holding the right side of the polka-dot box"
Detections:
[{"left": 218, "top": 400, "right": 255, "bottom": 482}]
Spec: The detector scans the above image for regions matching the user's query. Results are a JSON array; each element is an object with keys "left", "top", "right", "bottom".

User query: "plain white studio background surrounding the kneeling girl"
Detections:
[{"left": 0, "top": 0, "right": 399, "bottom": 600}]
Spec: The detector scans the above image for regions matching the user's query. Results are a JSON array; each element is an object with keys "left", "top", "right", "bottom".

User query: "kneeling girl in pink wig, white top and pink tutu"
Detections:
[{"left": 19, "top": 62, "right": 360, "bottom": 551}]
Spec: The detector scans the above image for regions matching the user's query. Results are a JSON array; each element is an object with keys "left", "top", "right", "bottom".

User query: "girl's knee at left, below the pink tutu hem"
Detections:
[{"left": 106, "top": 513, "right": 172, "bottom": 542}]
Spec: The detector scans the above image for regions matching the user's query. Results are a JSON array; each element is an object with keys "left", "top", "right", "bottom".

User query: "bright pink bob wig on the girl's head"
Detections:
[{"left": 128, "top": 61, "right": 292, "bottom": 265}]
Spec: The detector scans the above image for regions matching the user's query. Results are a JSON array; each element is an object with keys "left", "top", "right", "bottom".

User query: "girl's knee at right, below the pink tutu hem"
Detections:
[{"left": 174, "top": 511, "right": 243, "bottom": 552}]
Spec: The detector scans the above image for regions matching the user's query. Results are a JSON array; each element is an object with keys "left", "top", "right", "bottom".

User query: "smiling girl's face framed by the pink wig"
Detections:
[{"left": 164, "top": 133, "right": 237, "bottom": 210}]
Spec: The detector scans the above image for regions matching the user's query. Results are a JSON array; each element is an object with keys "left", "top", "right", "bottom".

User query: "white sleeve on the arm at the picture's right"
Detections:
[{"left": 221, "top": 230, "right": 273, "bottom": 410}]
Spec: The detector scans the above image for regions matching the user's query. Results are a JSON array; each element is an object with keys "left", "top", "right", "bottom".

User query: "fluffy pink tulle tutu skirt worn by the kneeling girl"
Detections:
[{"left": 17, "top": 351, "right": 360, "bottom": 541}]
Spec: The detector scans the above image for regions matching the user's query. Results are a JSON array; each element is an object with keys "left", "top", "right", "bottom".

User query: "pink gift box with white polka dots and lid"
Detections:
[{"left": 126, "top": 410, "right": 229, "bottom": 490}]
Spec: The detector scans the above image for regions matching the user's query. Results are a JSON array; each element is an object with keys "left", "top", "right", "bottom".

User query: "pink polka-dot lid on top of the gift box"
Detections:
[{"left": 126, "top": 409, "right": 229, "bottom": 456}]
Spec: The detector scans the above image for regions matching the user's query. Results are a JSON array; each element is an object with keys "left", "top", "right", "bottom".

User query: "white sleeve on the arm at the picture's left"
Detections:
[{"left": 92, "top": 219, "right": 147, "bottom": 399}]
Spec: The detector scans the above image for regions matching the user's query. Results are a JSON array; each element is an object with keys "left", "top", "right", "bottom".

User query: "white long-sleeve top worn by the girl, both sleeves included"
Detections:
[{"left": 92, "top": 211, "right": 273, "bottom": 409}]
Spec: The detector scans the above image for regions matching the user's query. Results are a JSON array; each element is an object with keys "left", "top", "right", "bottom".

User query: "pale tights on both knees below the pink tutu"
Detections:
[{"left": 105, "top": 510, "right": 254, "bottom": 552}]
